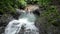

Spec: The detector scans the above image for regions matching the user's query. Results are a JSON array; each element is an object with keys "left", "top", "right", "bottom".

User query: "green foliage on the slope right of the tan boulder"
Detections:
[{"left": 39, "top": 0, "right": 60, "bottom": 26}]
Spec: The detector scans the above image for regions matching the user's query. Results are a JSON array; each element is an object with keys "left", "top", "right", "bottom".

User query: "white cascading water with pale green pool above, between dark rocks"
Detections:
[{"left": 5, "top": 9, "right": 39, "bottom": 34}]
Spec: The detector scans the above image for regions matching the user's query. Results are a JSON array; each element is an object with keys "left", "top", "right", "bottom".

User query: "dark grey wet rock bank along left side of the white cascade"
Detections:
[{"left": 0, "top": 14, "right": 13, "bottom": 34}]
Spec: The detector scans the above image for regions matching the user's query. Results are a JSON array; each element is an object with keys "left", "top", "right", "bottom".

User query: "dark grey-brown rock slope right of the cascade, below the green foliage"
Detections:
[{"left": 35, "top": 17, "right": 60, "bottom": 34}]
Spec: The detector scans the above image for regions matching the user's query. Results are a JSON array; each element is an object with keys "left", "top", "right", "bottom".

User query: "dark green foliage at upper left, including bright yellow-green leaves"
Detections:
[{"left": 0, "top": 0, "right": 27, "bottom": 13}]
